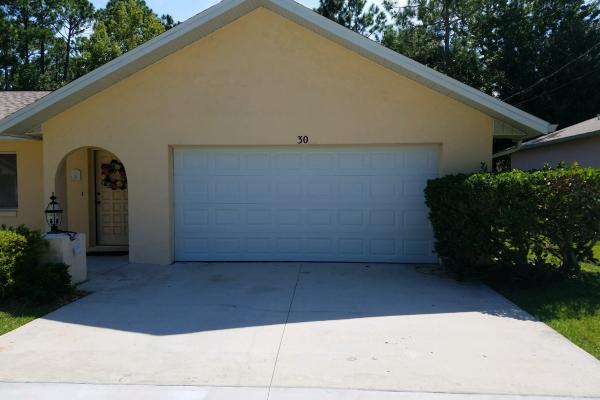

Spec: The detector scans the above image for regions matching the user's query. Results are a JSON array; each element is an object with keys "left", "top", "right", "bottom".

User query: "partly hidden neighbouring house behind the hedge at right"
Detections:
[{"left": 494, "top": 115, "right": 600, "bottom": 170}]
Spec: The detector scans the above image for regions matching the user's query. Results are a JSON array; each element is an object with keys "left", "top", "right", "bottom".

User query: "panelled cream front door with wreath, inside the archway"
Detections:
[{"left": 94, "top": 150, "right": 129, "bottom": 246}]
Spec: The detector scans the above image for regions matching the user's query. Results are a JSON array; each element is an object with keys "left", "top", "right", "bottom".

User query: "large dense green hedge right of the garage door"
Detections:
[{"left": 425, "top": 165, "right": 600, "bottom": 276}]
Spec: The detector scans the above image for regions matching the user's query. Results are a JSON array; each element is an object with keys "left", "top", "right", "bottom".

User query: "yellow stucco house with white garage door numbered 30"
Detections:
[{"left": 0, "top": 0, "right": 552, "bottom": 264}]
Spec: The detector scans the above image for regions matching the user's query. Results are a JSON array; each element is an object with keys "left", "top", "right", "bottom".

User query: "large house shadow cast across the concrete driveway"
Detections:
[{"left": 38, "top": 257, "right": 531, "bottom": 335}]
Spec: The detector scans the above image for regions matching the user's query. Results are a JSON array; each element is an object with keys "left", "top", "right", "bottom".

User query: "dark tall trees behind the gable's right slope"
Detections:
[{"left": 316, "top": 0, "right": 600, "bottom": 127}]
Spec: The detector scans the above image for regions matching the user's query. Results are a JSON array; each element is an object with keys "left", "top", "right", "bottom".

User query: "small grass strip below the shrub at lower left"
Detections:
[{"left": 0, "top": 291, "right": 86, "bottom": 335}]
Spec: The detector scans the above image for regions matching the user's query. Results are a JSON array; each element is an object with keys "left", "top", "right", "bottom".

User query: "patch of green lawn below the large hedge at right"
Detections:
[{"left": 499, "top": 243, "right": 600, "bottom": 359}]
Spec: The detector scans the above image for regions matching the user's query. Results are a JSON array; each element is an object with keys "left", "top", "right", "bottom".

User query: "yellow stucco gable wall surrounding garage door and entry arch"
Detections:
[{"left": 42, "top": 8, "right": 492, "bottom": 263}]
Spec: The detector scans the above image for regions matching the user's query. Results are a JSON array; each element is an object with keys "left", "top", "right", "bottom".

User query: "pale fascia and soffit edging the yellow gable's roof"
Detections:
[{"left": 0, "top": 0, "right": 553, "bottom": 137}]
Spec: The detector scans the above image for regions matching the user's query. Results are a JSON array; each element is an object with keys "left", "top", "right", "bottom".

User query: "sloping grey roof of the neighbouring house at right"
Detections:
[{"left": 494, "top": 115, "right": 600, "bottom": 157}]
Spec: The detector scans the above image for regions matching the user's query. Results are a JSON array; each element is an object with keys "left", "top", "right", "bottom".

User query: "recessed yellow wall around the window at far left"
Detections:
[{"left": 0, "top": 140, "right": 46, "bottom": 229}]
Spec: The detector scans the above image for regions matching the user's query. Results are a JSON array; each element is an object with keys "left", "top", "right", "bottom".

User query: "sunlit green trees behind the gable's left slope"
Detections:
[{"left": 0, "top": 0, "right": 175, "bottom": 90}]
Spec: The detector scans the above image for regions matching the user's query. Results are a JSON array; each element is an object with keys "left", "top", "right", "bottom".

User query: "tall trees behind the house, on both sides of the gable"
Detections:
[{"left": 0, "top": 0, "right": 600, "bottom": 126}]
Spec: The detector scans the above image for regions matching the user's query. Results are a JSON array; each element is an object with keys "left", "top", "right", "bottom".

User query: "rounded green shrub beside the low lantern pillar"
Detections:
[{"left": 0, "top": 226, "right": 73, "bottom": 303}]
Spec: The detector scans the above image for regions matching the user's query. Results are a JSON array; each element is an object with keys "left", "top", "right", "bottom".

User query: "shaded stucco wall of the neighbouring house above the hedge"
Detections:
[{"left": 511, "top": 136, "right": 600, "bottom": 171}]
